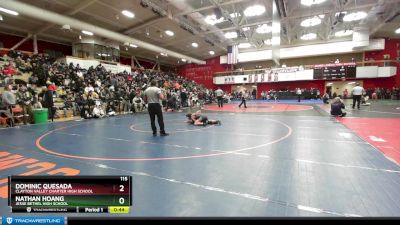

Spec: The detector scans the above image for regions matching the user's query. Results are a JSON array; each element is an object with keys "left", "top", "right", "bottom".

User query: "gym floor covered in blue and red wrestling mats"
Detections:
[{"left": 0, "top": 100, "right": 400, "bottom": 217}]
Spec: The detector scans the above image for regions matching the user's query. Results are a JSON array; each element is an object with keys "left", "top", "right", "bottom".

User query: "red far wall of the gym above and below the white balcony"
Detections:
[{"left": 178, "top": 39, "right": 400, "bottom": 94}]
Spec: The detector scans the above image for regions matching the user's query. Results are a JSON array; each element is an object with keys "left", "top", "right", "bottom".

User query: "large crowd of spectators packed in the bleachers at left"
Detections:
[{"left": 0, "top": 52, "right": 215, "bottom": 123}]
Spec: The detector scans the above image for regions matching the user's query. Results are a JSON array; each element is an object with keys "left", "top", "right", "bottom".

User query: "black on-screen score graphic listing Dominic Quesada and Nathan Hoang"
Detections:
[{"left": 8, "top": 176, "right": 132, "bottom": 213}]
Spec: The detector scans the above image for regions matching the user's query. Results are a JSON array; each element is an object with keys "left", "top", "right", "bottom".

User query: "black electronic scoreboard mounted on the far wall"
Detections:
[{"left": 314, "top": 63, "right": 357, "bottom": 80}]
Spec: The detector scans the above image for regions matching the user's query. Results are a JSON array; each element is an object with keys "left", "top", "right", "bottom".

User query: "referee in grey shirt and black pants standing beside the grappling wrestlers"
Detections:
[{"left": 144, "top": 80, "right": 169, "bottom": 136}]
